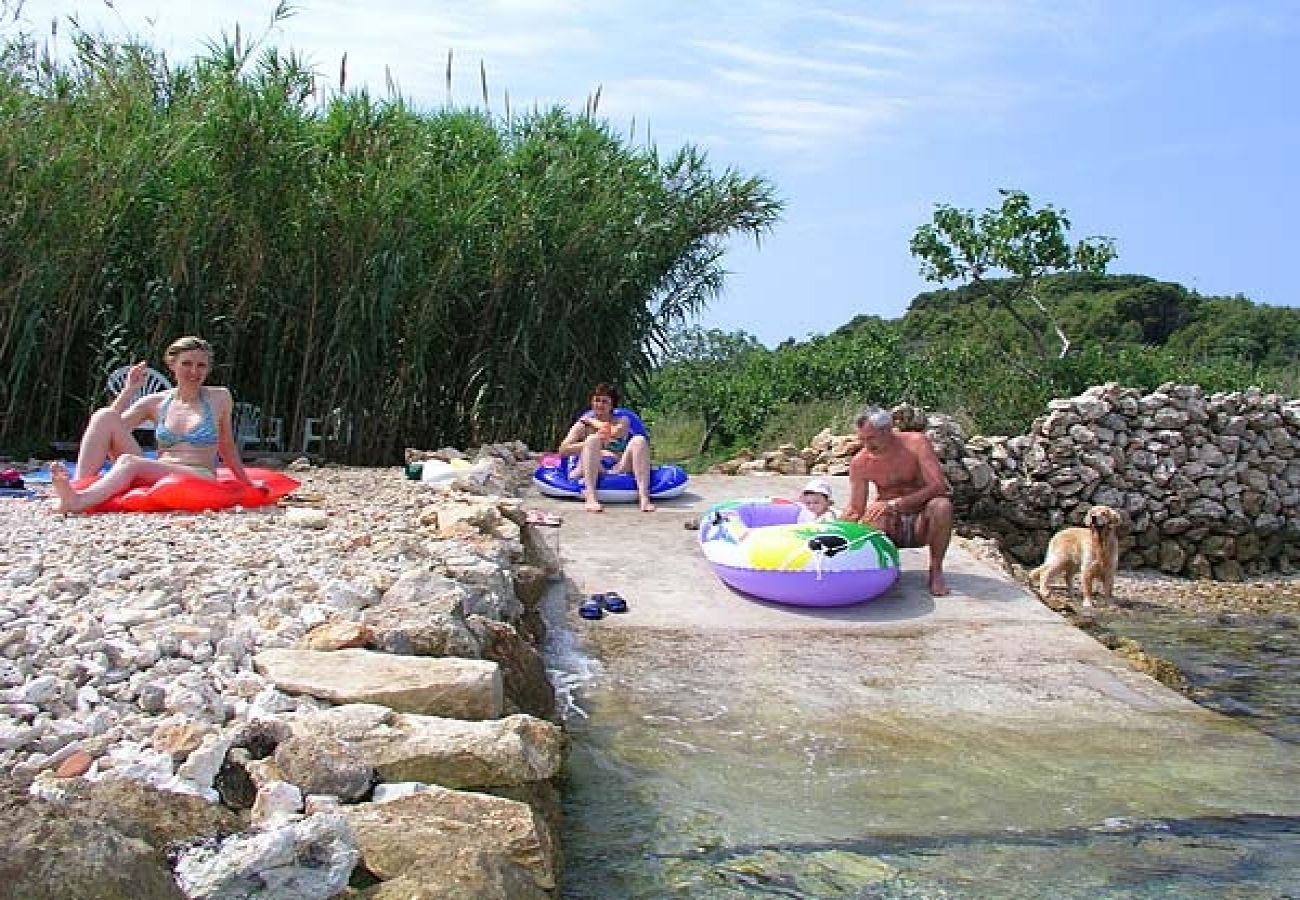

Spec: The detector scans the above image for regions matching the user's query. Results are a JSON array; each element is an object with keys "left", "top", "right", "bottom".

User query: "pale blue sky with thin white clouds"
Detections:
[{"left": 20, "top": 0, "right": 1300, "bottom": 346}]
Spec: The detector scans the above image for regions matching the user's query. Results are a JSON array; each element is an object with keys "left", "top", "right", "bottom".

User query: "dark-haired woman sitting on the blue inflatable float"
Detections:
[{"left": 558, "top": 384, "right": 654, "bottom": 512}]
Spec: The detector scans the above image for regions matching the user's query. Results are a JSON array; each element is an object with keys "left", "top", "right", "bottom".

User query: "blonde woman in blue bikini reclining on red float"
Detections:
[{"left": 49, "top": 337, "right": 265, "bottom": 512}]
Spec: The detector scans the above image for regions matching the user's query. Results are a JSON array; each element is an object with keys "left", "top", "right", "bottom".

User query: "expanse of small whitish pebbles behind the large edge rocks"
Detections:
[{"left": 0, "top": 452, "right": 548, "bottom": 778}]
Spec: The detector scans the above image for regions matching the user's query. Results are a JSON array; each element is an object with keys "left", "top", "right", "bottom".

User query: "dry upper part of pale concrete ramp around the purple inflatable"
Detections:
[{"left": 545, "top": 476, "right": 1197, "bottom": 714}]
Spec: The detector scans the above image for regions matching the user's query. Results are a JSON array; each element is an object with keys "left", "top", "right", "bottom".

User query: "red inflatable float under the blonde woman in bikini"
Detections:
[{"left": 73, "top": 468, "right": 298, "bottom": 512}]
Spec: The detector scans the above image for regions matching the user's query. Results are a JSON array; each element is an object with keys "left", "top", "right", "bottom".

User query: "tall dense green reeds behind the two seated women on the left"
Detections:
[{"left": 0, "top": 17, "right": 780, "bottom": 463}]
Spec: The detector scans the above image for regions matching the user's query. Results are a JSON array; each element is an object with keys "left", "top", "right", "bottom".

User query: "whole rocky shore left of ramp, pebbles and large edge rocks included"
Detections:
[{"left": 0, "top": 443, "right": 564, "bottom": 900}]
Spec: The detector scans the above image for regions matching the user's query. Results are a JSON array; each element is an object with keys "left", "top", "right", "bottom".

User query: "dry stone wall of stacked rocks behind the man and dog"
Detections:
[{"left": 735, "top": 384, "right": 1300, "bottom": 581}]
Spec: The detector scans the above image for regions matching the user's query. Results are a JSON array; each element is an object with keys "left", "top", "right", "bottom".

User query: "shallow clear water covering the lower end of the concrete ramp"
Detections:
[{"left": 549, "top": 592, "right": 1300, "bottom": 900}]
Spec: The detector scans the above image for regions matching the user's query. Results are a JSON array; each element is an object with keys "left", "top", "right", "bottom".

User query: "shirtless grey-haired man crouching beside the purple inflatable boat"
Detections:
[{"left": 844, "top": 407, "right": 953, "bottom": 597}]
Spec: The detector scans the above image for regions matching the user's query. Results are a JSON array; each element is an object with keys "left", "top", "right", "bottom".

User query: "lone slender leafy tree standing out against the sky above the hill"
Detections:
[{"left": 911, "top": 189, "right": 1115, "bottom": 360}]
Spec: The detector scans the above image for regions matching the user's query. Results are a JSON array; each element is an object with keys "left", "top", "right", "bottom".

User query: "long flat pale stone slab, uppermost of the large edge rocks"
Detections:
[{"left": 254, "top": 649, "right": 504, "bottom": 719}]
